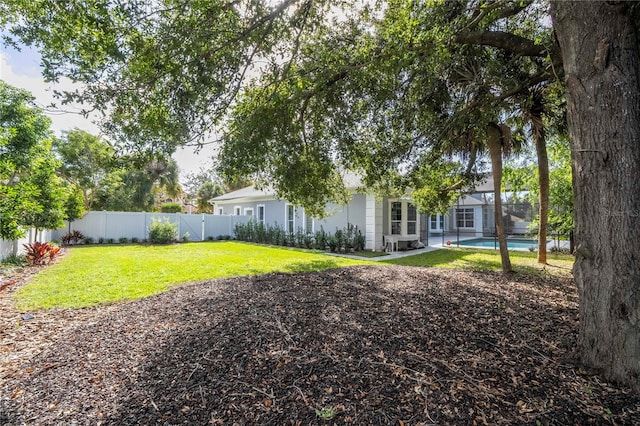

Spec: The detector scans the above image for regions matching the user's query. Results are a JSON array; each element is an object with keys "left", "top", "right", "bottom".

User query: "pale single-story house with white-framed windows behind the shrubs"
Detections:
[{"left": 211, "top": 176, "right": 528, "bottom": 251}]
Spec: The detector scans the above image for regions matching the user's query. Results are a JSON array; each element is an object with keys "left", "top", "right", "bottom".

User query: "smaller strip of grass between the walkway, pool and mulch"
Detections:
[{"left": 383, "top": 247, "right": 573, "bottom": 275}]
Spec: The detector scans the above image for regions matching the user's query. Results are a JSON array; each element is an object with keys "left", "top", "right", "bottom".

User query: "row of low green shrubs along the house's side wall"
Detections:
[{"left": 235, "top": 220, "right": 365, "bottom": 253}]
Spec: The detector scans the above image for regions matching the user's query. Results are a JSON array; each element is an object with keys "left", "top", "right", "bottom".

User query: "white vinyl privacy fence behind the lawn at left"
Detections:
[{"left": 0, "top": 211, "right": 250, "bottom": 260}]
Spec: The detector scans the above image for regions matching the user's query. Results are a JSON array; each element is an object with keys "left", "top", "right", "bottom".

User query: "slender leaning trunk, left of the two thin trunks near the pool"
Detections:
[{"left": 487, "top": 123, "right": 512, "bottom": 272}]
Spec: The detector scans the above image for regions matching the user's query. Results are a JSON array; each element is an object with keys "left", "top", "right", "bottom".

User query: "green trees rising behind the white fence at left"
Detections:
[{"left": 0, "top": 80, "right": 227, "bottom": 240}]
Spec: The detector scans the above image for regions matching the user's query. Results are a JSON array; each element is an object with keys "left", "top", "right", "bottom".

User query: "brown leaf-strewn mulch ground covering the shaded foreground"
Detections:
[{"left": 0, "top": 266, "right": 640, "bottom": 425}]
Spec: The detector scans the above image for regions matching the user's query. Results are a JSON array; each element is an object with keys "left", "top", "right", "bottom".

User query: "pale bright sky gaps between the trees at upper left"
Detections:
[{"left": 0, "top": 44, "right": 212, "bottom": 176}]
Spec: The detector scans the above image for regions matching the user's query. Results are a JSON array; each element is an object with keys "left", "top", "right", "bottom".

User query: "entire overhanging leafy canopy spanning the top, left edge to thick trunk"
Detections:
[{"left": 0, "top": 0, "right": 561, "bottom": 213}]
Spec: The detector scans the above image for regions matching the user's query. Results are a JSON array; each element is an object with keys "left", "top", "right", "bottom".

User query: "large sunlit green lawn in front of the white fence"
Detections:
[{"left": 15, "top": 242, "right": 368, "bottom": 310}]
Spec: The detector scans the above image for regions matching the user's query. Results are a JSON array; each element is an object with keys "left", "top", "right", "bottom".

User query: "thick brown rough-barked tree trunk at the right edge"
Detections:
[{"left": 552, "top": 1, "right": 640, "bottom": 391}]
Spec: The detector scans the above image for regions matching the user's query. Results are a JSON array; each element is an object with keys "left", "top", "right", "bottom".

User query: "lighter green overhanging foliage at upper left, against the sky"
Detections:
[{"left": 3, "top": 0, "right": 333, "bottom": 153}]
